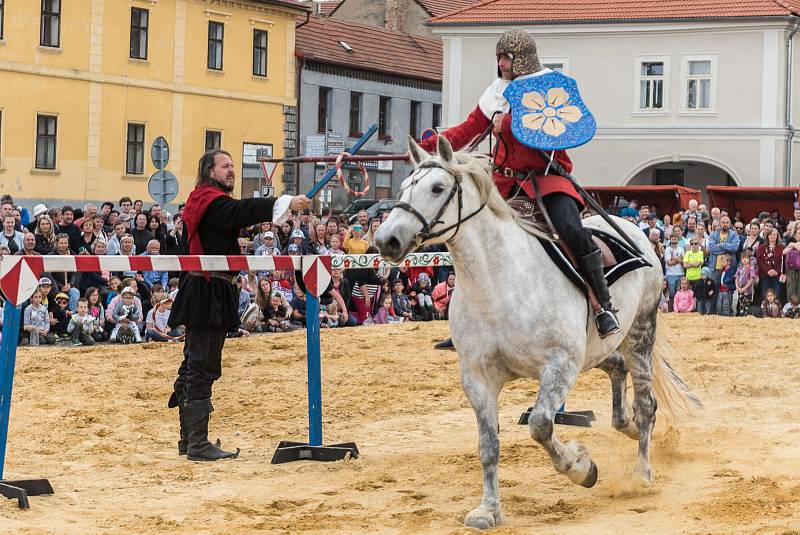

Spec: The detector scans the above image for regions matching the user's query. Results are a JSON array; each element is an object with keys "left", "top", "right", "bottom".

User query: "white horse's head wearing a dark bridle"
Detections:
[{"left": 375, "top": 136, "right": 491, "bottom": 261}]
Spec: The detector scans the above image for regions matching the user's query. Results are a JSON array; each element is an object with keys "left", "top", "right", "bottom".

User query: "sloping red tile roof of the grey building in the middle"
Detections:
[{"left": 295, "top": 17, "right": 442, "bottom": 82}]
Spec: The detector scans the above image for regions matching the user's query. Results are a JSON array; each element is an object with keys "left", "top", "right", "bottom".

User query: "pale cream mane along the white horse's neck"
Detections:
[{"left": 440, "top": 151, "right": 553, "bottom": 240}]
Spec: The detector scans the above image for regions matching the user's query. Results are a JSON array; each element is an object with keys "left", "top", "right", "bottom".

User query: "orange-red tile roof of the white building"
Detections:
[{"left": 429, "top": 0, "right": 800, "bottom": 25}]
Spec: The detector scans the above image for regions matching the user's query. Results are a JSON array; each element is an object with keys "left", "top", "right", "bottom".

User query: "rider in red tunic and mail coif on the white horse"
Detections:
[{"left": 420, "top": 30, "right": 620, "bottom": 347}]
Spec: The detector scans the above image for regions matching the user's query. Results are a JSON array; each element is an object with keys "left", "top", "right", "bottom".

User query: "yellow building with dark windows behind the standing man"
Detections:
[{"left": 0, "top": 0, "right": 307, "bottom": 204}]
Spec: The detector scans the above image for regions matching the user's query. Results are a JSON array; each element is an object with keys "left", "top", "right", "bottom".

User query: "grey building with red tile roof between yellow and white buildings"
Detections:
[{"left": 297, "top": 17, "right": 442, "bottom": 210}]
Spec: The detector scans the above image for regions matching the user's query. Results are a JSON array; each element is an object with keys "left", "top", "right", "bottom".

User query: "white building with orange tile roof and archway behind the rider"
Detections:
[{"left": 428, "top": 0, "right": 800, "bottom": 193}]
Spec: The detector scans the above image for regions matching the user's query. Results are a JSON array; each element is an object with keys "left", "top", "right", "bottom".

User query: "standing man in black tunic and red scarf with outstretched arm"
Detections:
[{"left": 169, "top": 149, "right": 311, "bottom": 461}]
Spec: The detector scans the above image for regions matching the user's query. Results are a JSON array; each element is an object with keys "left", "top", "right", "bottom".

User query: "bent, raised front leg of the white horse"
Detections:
[{"left": 528, "top": 357, "right": 597, "bottom": 488}]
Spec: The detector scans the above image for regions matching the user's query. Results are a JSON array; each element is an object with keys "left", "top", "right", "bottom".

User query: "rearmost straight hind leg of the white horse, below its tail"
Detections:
[{"left": 625, "top": 309, "right": 657, "bottom": 486}]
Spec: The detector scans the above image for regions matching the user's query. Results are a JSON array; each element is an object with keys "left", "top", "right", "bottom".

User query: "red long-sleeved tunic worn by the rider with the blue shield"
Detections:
[{"left": 420, "top": 107, "right": 583, "bottom": 206}]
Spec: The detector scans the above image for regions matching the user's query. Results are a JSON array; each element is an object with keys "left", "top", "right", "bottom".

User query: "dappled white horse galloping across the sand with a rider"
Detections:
[{"left": 376, "top": 136, "right": 699, "bottom": 528}]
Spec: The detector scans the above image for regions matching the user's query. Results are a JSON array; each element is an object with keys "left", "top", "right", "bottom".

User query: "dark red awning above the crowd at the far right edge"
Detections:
[{"left": 707, "top": 186, "right": 800, "bottom": 221}]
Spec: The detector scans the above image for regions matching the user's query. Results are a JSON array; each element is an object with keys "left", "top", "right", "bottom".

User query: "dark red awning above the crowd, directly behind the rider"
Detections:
[{"left": 585, "top": 186, "right": 703, "bottom": 216}]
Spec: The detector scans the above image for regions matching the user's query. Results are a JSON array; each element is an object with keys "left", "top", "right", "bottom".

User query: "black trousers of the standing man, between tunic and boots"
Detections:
[{"left": 175, "top": 326, "right": 227, "bottom": 401}]
